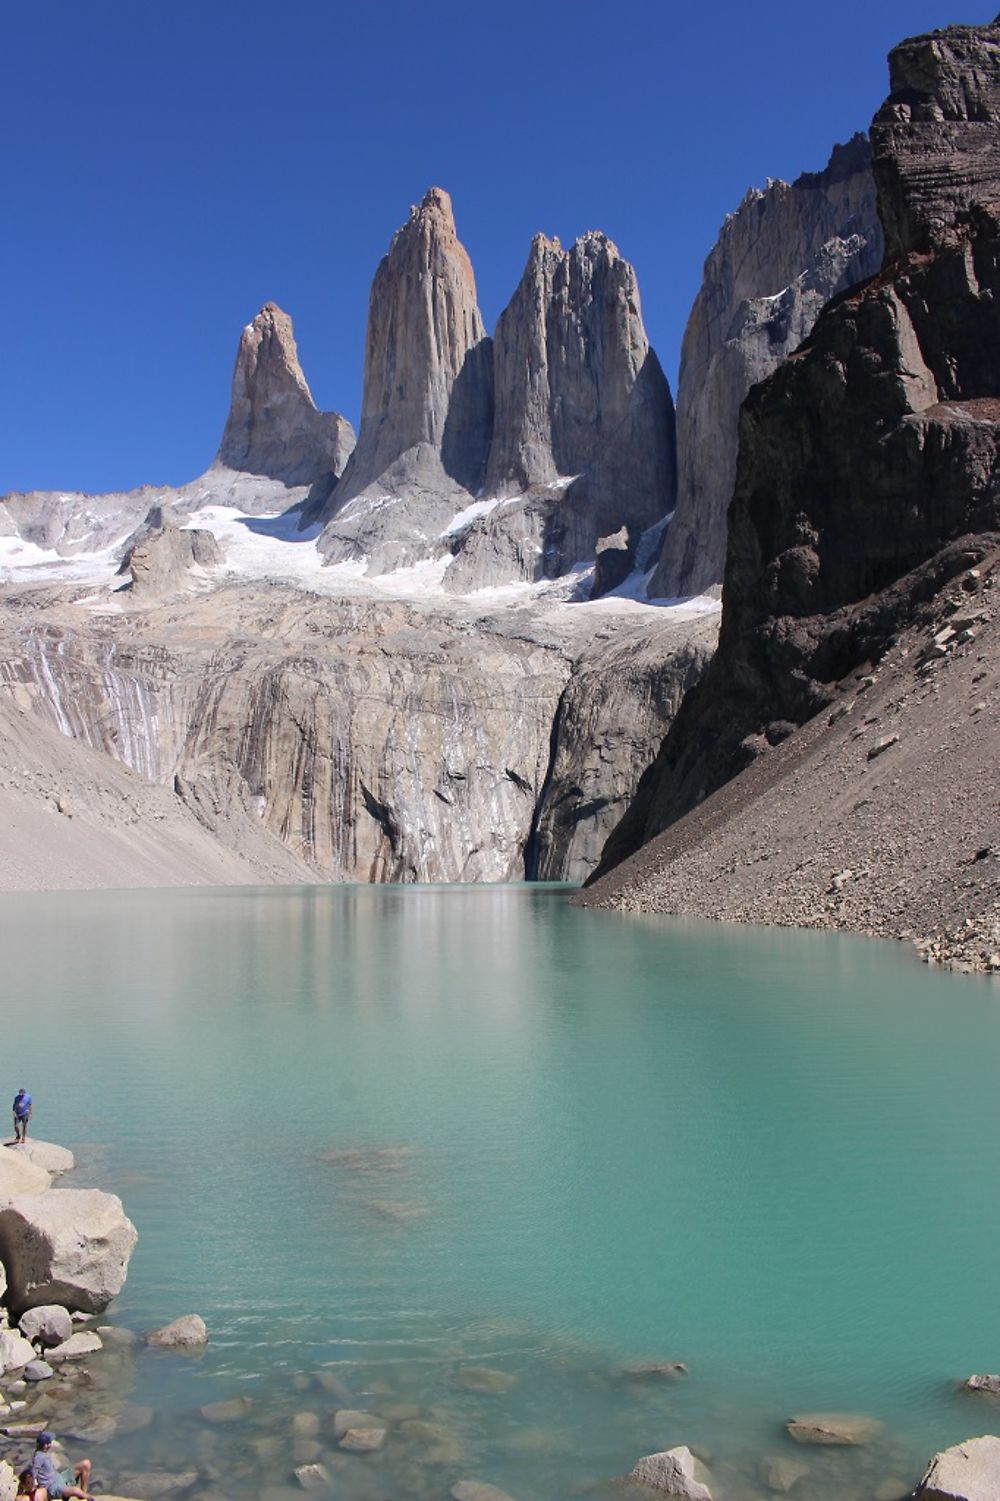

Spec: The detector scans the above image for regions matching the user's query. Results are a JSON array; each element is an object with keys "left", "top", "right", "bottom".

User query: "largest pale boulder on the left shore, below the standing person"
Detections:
[{"left": 0, "top": 1168, "right": 137, "bottom": 1313}]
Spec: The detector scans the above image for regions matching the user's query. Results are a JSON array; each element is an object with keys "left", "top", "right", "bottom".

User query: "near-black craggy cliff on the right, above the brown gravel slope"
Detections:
[{"left": 579, "top": 17, "right": 1000, "bottom": 972}]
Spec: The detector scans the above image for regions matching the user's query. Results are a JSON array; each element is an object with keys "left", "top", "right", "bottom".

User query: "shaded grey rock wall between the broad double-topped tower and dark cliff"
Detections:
[{"left": 650, "top": 135, "right": 883, "bottom": 597}]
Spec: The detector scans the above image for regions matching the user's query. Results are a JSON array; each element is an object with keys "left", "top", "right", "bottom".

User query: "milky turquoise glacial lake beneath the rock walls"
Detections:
[{"left": 0, "top": 887, "right": 1000, "bottom": 1501}]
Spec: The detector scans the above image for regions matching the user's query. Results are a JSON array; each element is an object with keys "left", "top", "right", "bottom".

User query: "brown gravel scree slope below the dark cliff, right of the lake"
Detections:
[{"left": 577, "top": 552, "right": 1000, "bottom": 973}]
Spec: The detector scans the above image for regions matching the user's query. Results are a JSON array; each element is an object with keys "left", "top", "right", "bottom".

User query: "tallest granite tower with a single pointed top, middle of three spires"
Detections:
[{"left": 320, "top": 188, "right": 492, "bottom": 573}]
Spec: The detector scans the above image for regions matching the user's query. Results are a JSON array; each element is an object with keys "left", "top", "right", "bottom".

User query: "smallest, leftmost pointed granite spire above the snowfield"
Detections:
[{"left": 215, "top": 302, "right": 354, "bottom": 485}]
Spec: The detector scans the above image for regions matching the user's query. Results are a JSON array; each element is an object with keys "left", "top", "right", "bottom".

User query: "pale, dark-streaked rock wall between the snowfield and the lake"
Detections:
[{"left": 0, "top": 581, "right": 716, "bottom": 881}]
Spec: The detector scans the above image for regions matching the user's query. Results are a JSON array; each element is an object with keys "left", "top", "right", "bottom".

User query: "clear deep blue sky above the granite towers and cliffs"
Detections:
[{"left": 0, "top": 0, "right": 966, "bottom": 492}]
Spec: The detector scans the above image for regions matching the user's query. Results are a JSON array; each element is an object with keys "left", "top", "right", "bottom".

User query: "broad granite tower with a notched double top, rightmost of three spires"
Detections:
[{"left": 447, "top": 231, "right": 674, "bottom": 590}]
